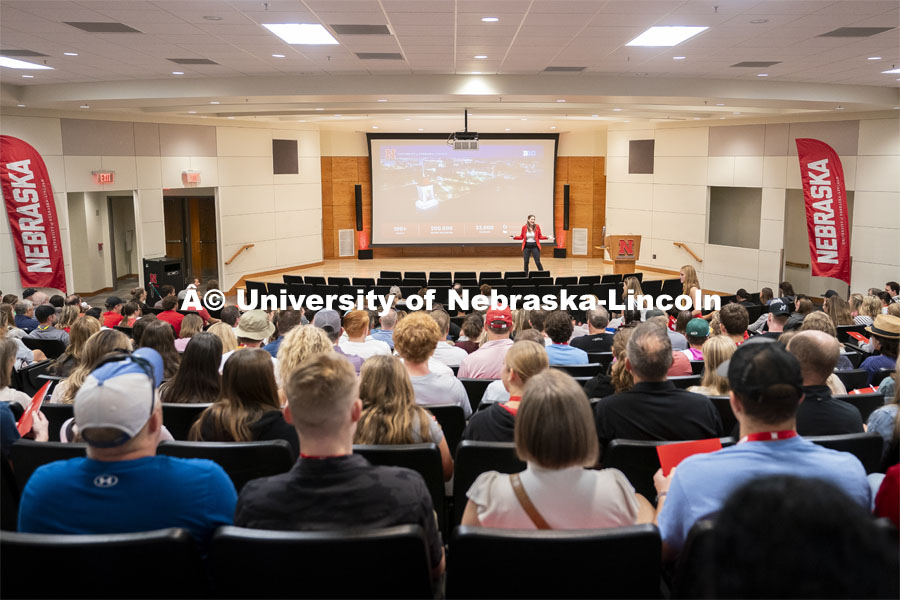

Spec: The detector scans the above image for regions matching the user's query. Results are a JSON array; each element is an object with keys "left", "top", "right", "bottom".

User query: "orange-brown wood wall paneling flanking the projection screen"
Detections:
[{"left": 322, "top": 156, "right": 606, "bottom": 258}]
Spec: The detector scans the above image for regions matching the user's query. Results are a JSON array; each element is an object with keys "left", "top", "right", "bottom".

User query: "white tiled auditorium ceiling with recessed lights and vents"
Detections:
[{"left": 0, "top": 0, "right": 900, "bottom": 131}]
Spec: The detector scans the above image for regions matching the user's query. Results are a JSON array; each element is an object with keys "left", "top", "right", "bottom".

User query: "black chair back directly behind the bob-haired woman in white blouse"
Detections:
[{"left": 447, "top": 524, "right": 662, "bottom": 598}]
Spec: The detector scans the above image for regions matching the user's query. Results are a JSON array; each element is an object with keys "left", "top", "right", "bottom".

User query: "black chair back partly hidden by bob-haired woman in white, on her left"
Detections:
[{"left": 453, "top": 440, "right": 525, "bottom": 524}]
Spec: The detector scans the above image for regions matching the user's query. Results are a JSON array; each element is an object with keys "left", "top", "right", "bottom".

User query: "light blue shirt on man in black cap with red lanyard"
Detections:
[{"left": 659, "top": 436, "right": 872, "bottom": 549}]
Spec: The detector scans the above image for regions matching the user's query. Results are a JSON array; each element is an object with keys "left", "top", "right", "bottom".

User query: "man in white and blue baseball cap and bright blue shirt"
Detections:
[{"left": 18, "top": 348, "right": 237, "bottom": 544}]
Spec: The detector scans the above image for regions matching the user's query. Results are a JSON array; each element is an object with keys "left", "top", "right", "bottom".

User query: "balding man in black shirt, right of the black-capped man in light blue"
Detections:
[{"left": 787, "top": 331, "right": 863, "bottom": 435}]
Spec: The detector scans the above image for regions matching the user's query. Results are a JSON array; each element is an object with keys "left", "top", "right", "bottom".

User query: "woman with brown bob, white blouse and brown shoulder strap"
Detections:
[{"left": 462, "top": 370, "right": 653, "bottom": 529}]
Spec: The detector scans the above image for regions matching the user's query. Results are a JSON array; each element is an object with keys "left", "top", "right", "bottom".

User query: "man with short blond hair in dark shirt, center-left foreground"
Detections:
[{"left": 234, "top": 353, "right": 444, "bottom": 578}]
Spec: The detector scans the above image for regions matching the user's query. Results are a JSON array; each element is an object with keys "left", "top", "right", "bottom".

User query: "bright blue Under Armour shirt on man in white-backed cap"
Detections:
[{"left": 19, "top": 456, "right": 237, "bottom": 545}]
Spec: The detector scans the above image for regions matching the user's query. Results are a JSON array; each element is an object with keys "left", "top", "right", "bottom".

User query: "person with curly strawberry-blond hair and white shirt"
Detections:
[{"left": 394, "top": 312, "right": 475, "bottom": 419}]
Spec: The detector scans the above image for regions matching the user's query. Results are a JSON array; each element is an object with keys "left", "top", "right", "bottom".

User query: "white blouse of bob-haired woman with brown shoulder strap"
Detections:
[{"left": 466, "top": 462, "right": 638, "bottom": 529}]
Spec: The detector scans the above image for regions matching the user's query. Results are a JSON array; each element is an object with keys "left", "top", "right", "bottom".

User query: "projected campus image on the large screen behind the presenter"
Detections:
[{"left": 371, "top": 139, "right": 556, "bottom": 244}]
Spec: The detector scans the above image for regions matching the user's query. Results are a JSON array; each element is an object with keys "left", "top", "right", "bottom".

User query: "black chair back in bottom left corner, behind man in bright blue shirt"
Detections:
[{"left": 0, "top": 528, "right": 205, "bottom": 598}]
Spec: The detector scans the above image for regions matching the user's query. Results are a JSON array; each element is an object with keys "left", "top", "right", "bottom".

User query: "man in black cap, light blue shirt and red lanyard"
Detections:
[{"left": 653, "top": 338, "right": 872, "bottom": 558}]
